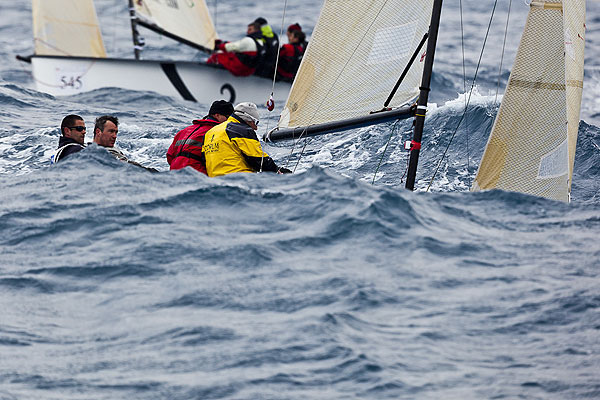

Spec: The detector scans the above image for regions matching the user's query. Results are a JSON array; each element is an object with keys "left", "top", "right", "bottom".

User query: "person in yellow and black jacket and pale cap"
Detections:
[{"left": 202, "top": 102, "right": 292, "bottom": 176}]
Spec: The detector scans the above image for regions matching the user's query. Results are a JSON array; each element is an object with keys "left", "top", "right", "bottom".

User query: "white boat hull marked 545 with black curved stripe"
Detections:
[{"left": 31, "top": 56, "right": 291, "bottom": 104}]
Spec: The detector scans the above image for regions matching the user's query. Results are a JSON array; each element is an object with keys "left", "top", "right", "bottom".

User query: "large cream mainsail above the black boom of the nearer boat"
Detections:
[{"left": 279, "top": 0, "right": 433, "bottom": 127}]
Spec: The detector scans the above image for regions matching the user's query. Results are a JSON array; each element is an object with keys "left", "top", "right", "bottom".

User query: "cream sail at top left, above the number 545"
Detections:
[{"left": 32, "top": 0, "right": 106, "bottom": 57}]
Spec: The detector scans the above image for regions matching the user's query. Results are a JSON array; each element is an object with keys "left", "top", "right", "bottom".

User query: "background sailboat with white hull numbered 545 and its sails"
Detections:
[{"left": 18, "top": 0, "right": 291, "bottom": 104}]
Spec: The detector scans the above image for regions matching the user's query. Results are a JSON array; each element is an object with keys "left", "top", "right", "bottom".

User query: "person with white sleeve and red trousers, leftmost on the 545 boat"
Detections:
[{"left": 206, "top": 22, "right": 266, "bottom": 76}]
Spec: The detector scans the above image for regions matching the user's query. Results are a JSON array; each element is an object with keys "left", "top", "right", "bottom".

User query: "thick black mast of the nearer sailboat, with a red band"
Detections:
[{"left": 406, "top": 0, "right": 442, "bottom": 190}]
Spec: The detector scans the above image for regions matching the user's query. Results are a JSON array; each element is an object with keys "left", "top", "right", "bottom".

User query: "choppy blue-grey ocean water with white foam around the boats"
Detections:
[{"left": 0, "top": 0, "right": 600, "bottom": 400}]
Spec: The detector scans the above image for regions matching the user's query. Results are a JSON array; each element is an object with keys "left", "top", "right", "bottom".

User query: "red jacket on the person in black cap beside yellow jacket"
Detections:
[{"left": 167, "top": 116, "right": 219, "bottom": 174}]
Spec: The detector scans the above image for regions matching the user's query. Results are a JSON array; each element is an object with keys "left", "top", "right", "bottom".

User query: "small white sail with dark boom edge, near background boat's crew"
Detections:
[{"left": 134, "top": 0, "right": 217, "bottom": 49}]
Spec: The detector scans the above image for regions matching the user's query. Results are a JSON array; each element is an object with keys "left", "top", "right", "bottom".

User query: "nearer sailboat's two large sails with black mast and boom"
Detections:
[{"left": 264, "top": 0, "right": 585, "bottom": 201}]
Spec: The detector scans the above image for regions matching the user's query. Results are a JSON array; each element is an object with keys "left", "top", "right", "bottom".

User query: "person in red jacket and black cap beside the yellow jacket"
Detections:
[{"left": 167, "top": 100, "right": 233, "bottom": 174}]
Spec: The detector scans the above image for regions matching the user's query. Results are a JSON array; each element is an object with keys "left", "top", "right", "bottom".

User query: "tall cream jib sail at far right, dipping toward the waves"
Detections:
[{"left": 473, "top": 0, "right": 585, "bottom": 201}]
